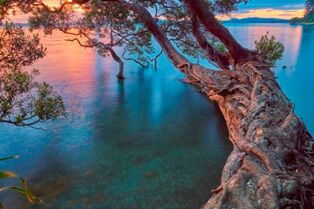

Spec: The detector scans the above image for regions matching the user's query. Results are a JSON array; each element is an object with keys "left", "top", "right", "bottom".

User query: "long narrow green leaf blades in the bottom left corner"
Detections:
[{"left": 0, "top": 155, "right": 41, "bottom": 209}]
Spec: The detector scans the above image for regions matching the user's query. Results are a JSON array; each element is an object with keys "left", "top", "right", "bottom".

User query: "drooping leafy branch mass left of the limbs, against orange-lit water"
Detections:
[{"left": 29, "top": 0, "right": 154, "bottom": 64}]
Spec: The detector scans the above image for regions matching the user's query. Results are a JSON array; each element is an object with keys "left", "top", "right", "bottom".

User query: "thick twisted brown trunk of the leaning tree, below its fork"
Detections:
[{"left": 202, "top": 62, "right": 314, "bottom": 209}]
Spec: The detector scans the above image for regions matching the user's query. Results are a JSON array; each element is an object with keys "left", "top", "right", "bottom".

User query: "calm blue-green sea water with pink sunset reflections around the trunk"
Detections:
[{"left": 0, "top": 24, "right": 314, "bottom": 209}]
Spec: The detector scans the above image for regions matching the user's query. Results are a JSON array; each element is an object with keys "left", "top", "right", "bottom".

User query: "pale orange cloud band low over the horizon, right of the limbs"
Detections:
[{"left": 218, "top": 8, "right": 304, "bottom": 20}]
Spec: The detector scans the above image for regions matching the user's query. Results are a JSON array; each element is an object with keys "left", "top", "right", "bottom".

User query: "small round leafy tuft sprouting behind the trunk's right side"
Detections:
[{"left": 255, "top": 33, "right": 285, "bottom": 65}]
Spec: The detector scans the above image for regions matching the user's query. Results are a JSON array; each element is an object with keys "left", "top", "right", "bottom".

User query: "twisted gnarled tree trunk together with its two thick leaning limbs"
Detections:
[{"left": 121, "top": 0, "right": 314, "bottom": 209}]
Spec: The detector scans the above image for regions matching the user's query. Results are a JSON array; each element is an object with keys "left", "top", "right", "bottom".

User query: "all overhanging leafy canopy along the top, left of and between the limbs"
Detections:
[{"left": 2, "top": 0, "right": 260, "bottom": 68}]
